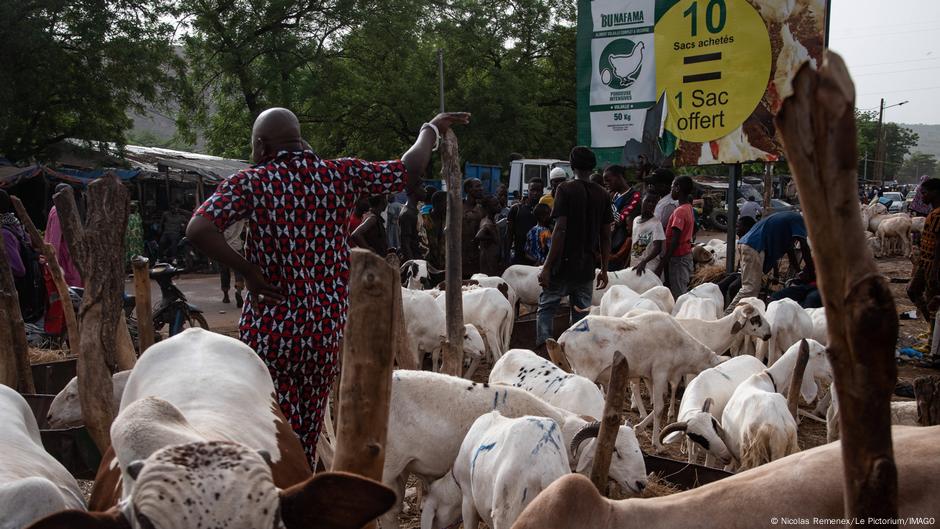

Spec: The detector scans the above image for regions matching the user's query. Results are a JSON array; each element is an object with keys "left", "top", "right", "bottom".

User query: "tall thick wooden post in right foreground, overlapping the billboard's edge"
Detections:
[{"left": 775, "top": 52, "right": 898, "bottom": 527}]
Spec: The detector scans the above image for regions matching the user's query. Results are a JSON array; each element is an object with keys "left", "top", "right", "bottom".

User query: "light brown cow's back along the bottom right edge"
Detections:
[{"left": 512, "top": 426, "right": 940, "bottom": 529}]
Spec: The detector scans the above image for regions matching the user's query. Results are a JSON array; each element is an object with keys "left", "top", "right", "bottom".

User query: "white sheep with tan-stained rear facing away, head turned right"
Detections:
[{"left": 721, "top": 340, "right": 832, "bottom": 470}]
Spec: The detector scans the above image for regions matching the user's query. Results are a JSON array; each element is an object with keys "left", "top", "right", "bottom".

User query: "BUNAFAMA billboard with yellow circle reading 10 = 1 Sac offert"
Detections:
[{"left": 578, "top": 0, "right": 827, "bottom": 165}]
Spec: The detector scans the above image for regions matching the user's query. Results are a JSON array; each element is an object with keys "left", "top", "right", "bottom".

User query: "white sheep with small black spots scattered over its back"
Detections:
[{"left": 490, "top": 349, "right": 604, "bottom": 419}]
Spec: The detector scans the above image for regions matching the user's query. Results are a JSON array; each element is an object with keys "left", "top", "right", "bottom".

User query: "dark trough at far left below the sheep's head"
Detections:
[{"left": 23, "top": 392, "right": 101, "bottom": 479}]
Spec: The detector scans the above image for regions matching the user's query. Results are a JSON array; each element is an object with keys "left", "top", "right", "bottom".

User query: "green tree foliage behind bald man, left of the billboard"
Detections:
[{"left": 173, "top": 0, "right": 575, "bottom": 164}]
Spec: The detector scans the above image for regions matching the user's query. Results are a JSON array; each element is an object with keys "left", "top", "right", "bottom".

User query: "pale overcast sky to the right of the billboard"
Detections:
[{"left": 829, "top": 0, "right": 940, "bottom": 124}]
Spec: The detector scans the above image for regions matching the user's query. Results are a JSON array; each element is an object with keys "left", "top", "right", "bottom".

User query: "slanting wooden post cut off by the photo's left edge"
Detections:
[{"left": 0, "top": 231, "right": 36, "bottom": 393}]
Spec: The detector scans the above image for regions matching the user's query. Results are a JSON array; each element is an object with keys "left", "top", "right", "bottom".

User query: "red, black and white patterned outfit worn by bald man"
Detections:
[{"left": 196, "top": 151, "right": 407, "bottom": 464}]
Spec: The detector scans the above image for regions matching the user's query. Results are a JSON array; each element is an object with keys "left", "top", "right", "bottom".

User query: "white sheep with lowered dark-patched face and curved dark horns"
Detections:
[{"left": 660, "top": 355, "right": 764, "bottom": 466}]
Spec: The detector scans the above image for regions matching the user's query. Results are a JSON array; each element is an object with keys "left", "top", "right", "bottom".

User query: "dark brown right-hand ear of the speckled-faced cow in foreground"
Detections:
[{"left": 281, "top": 472, "right": 397, "bottom": 529}]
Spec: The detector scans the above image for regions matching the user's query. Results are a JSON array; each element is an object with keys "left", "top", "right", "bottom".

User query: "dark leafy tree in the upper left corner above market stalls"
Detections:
[{"left": 0, "top": 0, "right": 183, "bottom": 161}]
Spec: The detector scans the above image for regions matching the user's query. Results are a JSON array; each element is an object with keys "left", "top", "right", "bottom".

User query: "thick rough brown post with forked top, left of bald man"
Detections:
[{"left": 55, "top": 174, "right": 130, "bottom": 453}]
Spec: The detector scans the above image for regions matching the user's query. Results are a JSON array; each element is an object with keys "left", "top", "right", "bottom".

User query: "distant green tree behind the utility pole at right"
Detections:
[{"left": 855, "top": 110, "right": 918, "bottom": 180}]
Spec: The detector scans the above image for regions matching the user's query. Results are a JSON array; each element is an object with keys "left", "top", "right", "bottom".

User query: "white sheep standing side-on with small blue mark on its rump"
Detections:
[{"left": 550, "top": 312, "right": 724, "bottom": 450}]
